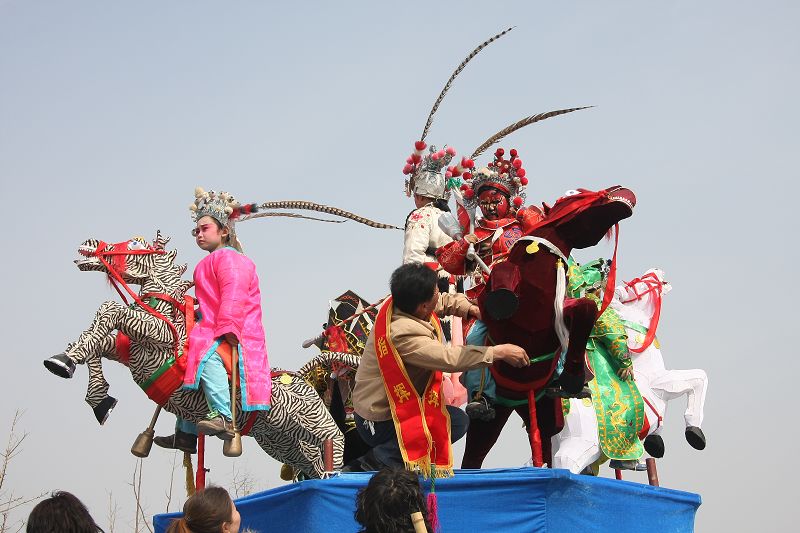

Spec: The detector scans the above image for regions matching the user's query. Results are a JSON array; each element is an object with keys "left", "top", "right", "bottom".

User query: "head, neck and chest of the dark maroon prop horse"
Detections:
[{"left": 479, "top": 186, "right": 636, "bottom": 391}]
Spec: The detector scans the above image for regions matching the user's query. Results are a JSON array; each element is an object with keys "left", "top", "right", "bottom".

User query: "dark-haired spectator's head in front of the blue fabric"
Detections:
[{"left": 355, "top": 467, "right": 433, "bottom": 533}]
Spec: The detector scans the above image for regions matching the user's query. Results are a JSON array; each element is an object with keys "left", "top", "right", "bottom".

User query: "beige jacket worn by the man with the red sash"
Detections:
[{"left": 353, "top": 294, "right": 494, "bottom": 422}]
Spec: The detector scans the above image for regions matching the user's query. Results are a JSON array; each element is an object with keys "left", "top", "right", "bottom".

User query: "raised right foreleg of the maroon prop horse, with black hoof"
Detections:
[{"left": 559, "top": 298, "right": 597, "bottom": 394}]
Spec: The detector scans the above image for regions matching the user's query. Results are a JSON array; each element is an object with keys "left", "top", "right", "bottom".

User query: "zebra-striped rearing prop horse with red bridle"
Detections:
[{"left": 45, "top": 232, "right": 344, "bottom": 478}]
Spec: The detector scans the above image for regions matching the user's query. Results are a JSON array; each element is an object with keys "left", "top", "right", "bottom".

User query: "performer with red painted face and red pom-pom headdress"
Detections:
[{"left": 436, "top": 148, "right": 544, "bottom": 420}]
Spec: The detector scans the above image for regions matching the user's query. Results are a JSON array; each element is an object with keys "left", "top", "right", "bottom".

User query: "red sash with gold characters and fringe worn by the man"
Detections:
[{"left": 373, "top": 298, "right": 453, "bottom": 477}]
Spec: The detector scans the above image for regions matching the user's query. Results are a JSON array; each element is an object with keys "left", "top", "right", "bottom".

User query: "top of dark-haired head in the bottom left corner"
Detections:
[{"left": 25, "top": 491, "right": 103, "bottom": 533}]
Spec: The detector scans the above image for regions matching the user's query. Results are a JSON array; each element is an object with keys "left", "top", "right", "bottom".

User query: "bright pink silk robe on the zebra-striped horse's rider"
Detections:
[{"left": 184, "top": 248, "right": 272, "bottom": 411}]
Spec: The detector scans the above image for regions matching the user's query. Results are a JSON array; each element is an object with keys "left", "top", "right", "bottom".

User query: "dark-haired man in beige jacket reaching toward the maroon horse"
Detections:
[{"left": 344, "top": 263, "right": 530, "bottom": 471}]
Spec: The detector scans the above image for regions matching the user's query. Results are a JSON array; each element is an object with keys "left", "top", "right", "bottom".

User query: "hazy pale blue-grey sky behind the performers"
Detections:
[{"left": 0, "top": 0, "right": 800, "bottom": 531}]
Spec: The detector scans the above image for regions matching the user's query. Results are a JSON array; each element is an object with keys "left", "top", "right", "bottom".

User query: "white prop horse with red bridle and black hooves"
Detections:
[{"left": 553, "top": 269, "right": 708, "bottom": 474}]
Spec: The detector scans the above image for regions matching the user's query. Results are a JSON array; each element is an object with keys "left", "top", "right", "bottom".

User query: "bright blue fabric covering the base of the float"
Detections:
[{"left": 153, "top": 468, "right": 700, "bottom": 533}]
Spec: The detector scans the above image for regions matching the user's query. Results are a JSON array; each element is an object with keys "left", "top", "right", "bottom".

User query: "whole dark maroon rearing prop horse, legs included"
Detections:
[{"left": 462, "top": 186, "right": 636, "bottom": 468}]
